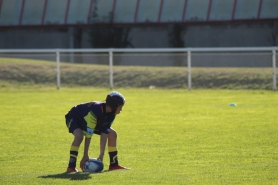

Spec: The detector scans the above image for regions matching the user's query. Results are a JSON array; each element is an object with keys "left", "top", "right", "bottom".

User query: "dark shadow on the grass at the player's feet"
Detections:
[{"left": 38, "top": 170, "right": 108, "bottom": 180}]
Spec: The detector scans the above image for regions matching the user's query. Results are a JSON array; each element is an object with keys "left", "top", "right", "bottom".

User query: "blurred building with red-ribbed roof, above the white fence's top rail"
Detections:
[{"left": 0, "top": 0, "right": 278, "bottom": 49}]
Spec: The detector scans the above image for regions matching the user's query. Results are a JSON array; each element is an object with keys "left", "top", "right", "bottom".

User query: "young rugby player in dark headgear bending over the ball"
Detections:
[{"left": 65, "top": 91, "right": 129, "bottom": 172}]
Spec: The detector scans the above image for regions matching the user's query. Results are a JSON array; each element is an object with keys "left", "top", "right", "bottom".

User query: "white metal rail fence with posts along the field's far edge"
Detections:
[{"left": 0, "top": 47, "right": 278, "bottom": 90}]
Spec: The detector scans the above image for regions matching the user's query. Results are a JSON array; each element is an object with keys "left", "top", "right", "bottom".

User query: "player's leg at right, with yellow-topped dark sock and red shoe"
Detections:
[{"left": 108, "top": 128, "right": 130, "bottom": 170}]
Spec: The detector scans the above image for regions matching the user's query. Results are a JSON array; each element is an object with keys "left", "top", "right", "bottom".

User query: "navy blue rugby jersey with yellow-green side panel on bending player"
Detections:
[{"left": 66, "top": 102, "right": 115, "bottom": 138}]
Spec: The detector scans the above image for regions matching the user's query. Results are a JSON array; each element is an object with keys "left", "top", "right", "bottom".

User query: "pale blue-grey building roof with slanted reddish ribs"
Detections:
[{"left": 0, "top": 0, "right": 278, "bottom": 27}]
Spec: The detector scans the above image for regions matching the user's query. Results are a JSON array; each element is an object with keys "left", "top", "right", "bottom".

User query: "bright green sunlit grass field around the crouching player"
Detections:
[{"left": 0, "top": 86, "right": 278, "bottom": 185}]
